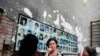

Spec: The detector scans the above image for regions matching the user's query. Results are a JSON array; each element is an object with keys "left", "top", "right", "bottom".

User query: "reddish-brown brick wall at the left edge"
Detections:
[{"left": 0, "top": 16, "right": 14, "bottom": 56}]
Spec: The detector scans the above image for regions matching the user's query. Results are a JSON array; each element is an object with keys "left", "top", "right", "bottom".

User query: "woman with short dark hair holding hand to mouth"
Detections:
[{"left": 45, "top": 38, "right": 61, "bottom": 56}]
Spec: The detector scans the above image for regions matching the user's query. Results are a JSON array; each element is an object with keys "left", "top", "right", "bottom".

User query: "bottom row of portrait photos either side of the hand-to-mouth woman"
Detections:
[{"left": 38, "top": 42, "right": 78, "bottom": 52}]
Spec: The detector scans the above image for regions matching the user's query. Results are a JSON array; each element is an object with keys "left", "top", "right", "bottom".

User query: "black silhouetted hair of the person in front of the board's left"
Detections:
[{"left": 19, "top": 34, "right": 38, "bottom": 56}]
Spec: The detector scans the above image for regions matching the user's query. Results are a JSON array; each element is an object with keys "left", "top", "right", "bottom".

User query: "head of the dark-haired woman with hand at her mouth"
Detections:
[{"left": 47, "top": 38, "right": 58, "bottom": 51}]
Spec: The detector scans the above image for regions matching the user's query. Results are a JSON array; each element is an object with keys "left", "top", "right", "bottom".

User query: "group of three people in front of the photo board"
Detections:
[{"left": 13, "top": 34, "right": 97, "bottom": 56}]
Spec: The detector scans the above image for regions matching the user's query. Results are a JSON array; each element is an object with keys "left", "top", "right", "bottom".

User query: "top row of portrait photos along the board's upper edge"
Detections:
[{"left": 18, "top": 16, "right": 77, "bottom": 41}]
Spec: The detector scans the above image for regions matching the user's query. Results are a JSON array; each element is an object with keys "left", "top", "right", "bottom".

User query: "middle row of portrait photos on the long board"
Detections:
[{"left": 18, "top": 25, "right": 77, "bottom": 44}]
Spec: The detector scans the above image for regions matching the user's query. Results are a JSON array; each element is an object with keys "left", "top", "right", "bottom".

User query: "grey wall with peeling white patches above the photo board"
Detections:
[{"left": 0, "top": 0, "right": 100, "bottom": 53}]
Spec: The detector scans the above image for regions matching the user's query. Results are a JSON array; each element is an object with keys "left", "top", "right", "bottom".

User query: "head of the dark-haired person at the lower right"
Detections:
[{"left": 83, "top": 46, "right": 97, "bottom": 56}]
